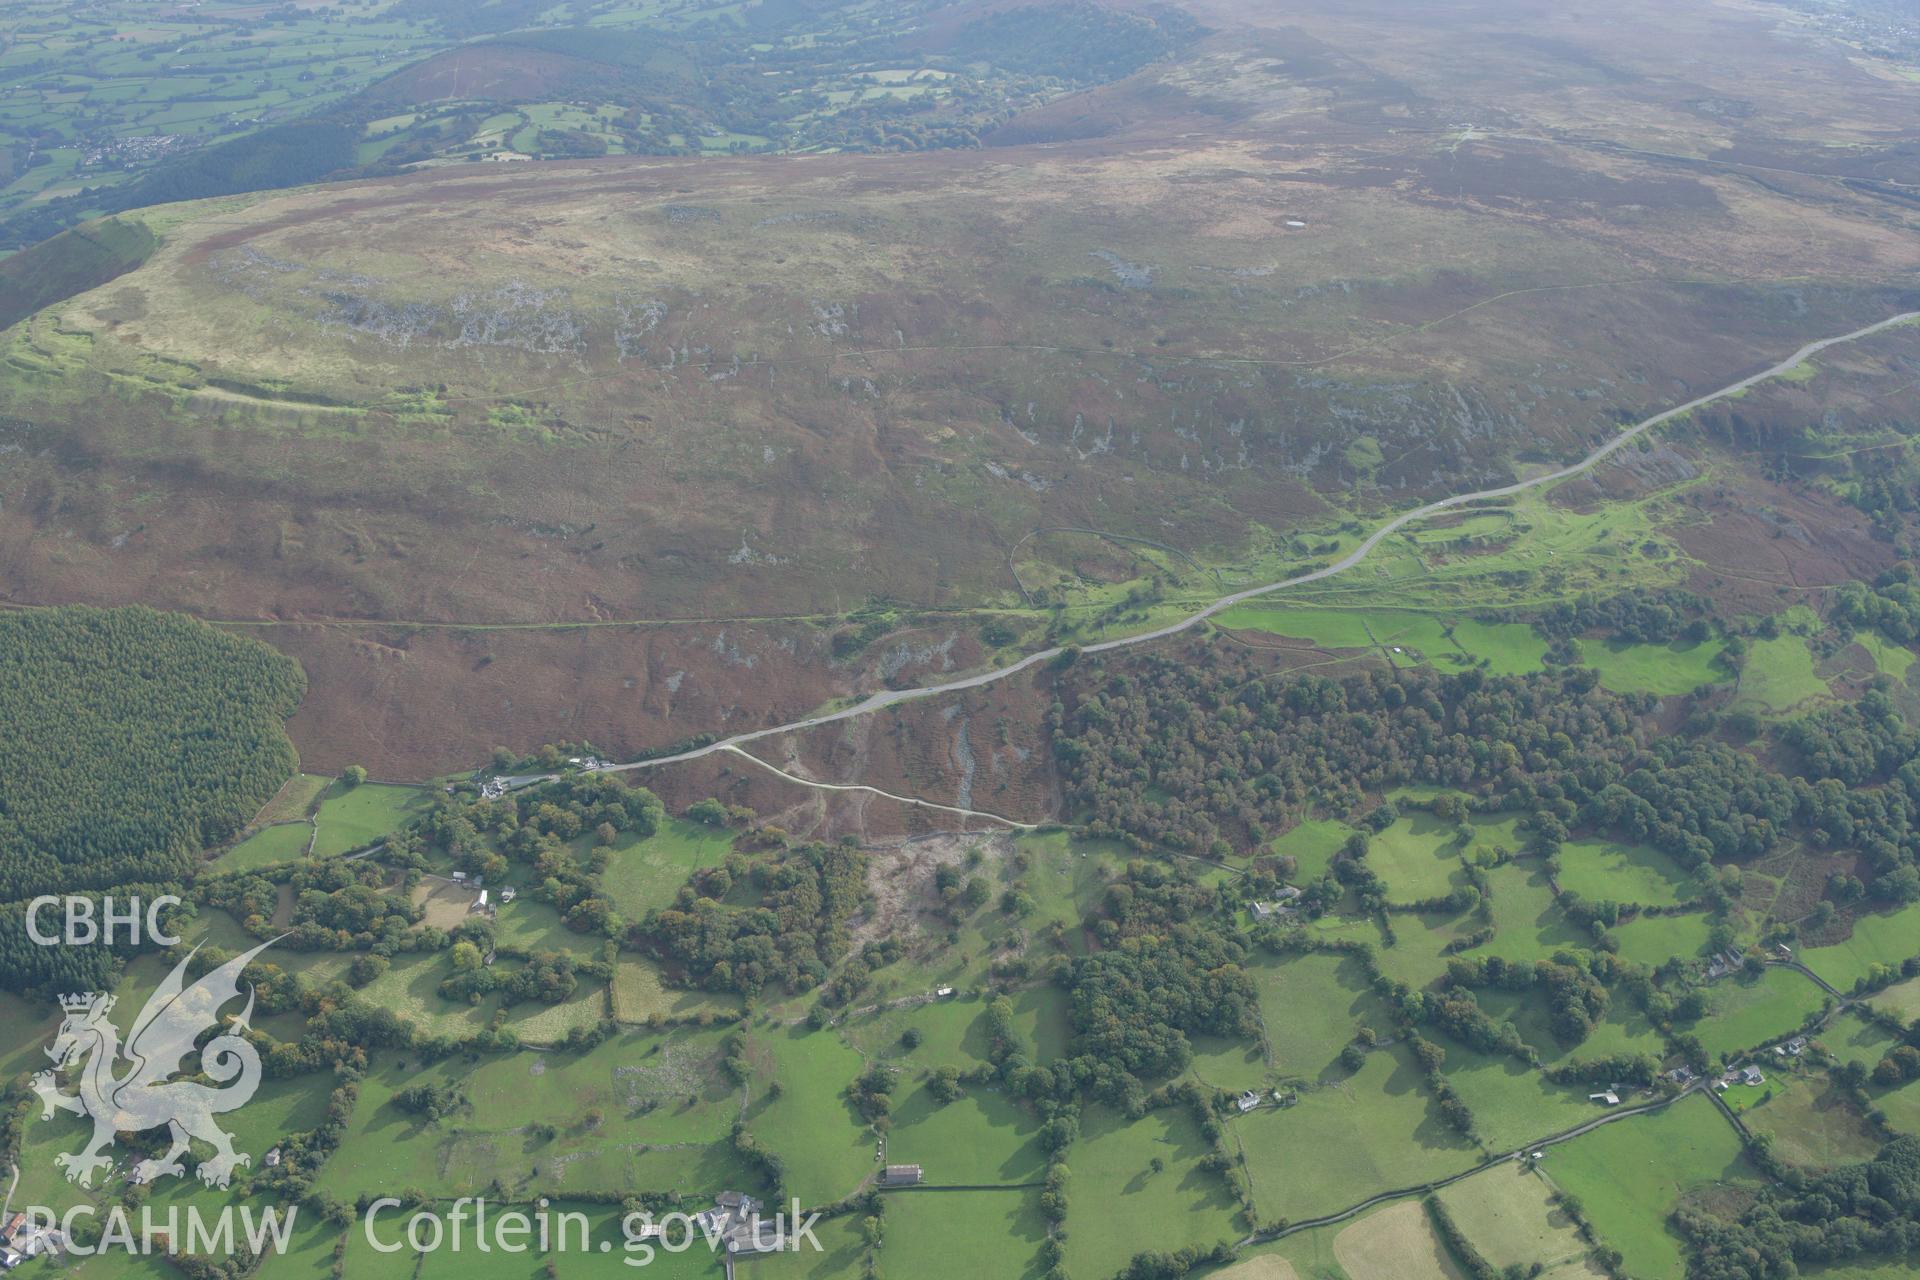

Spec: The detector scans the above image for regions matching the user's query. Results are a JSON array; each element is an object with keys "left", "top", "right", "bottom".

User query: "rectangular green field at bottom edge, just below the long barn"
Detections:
[{"left": 879, "top": 1190, "right": 1046, "bottom": 1280}]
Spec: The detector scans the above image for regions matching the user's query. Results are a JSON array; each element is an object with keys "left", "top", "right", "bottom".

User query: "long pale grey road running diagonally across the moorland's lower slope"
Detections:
[{"left": 605, "top": 311, "right": 1920, "bottom": 781}]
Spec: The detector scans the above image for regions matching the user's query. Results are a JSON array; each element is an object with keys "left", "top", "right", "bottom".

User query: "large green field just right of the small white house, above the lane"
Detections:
[{"left": 1229, "top": 1046, "right": 1480, "bottom": 1221}]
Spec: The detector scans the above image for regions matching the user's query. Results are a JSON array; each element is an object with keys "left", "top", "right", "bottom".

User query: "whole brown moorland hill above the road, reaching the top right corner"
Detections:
[{"left": 0, "top": 4, "right": 1920, "bottom": 760}]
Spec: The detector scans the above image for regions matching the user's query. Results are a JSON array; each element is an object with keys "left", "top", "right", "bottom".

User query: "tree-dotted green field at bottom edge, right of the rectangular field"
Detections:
[{"left": 1066, "top": 1105, "right": 1242, "bottom": 1276}]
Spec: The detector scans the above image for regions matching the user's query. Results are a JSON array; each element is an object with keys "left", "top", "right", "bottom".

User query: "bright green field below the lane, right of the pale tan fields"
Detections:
[{"left": 1540, "top": 1096, "right": 1761, "bottom": 1276}]
